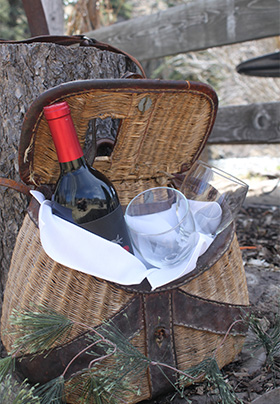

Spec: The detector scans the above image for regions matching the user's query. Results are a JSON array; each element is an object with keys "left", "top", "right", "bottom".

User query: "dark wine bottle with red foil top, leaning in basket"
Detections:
[{"left": 44, "top": 102, "right": 133, "bottom": 252}]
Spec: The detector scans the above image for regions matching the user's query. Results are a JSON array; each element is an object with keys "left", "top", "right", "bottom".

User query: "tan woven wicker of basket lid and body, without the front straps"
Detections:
[{"left": 1, "top": 80, "right": 249, "bottom": 404}]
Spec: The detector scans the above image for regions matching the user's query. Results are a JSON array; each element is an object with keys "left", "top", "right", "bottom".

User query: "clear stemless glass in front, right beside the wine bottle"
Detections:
[{"left": 125, "top": 187, "right": 195, "bottom": 268}]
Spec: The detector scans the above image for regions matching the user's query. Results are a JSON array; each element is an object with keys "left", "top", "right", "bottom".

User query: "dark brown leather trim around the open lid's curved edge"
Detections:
[{"left": 19, "top": 79, "right": 218, "bottom": 185}]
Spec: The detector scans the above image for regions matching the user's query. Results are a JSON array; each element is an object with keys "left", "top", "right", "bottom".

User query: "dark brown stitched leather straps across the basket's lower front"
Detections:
[{"left": 17, "top": 289, "right": 248, "bottom": 397}]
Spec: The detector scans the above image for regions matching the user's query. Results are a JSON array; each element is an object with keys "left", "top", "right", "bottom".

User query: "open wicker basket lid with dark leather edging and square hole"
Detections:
[{"left": 19, "top": 79, "right": 218, "bottom": 186}]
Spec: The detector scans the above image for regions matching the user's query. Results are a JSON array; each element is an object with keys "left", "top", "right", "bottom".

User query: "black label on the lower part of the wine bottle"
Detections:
[{"left": 52, "top": 202, "right": 133, "bottom": 253}]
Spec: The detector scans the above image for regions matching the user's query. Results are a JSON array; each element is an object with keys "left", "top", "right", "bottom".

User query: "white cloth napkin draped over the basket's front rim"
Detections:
[{"left": 31, "top": 191, "right": 220, "bottom": 290}]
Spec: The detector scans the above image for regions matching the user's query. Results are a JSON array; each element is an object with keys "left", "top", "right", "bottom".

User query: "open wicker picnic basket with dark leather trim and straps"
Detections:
[{"left": 2, "top": 79, "right": 249, "bottom": 404}]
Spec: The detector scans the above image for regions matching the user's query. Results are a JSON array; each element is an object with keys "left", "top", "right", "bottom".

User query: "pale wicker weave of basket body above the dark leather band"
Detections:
[{"left": 2, "top": 215, "right": 248, "bottom": 351}]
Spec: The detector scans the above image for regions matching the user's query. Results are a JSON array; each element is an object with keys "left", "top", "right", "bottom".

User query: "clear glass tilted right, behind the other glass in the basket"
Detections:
[{"left": 180, "top": 160, "right": 249, "bottom": 235}]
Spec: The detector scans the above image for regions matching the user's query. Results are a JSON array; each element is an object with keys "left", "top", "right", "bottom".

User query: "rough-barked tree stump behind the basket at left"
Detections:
[{"left": 0, "top": 43, "right": 136, "bottom": 342}]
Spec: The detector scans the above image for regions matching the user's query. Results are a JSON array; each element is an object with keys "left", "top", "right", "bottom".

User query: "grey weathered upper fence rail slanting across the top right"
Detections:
[{"left": 85, "top": 0, "right": 280, "bottom": 61}]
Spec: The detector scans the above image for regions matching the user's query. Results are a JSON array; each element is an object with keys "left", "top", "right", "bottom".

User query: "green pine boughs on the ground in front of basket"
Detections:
[{"left": 0, "top": 306, "right": 280, "bottom": 404}]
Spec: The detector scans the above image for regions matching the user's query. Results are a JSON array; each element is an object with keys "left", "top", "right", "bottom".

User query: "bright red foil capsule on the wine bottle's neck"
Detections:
[{"left": 44, "top": 102, "right": 83, "bottom": 164}]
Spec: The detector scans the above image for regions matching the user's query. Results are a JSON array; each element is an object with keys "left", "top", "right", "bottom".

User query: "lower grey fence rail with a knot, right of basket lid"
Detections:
[{"left": 208, "top": 102, "right": 280, "bottom": 144}]
